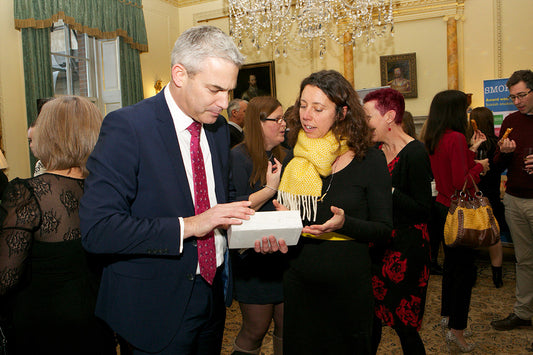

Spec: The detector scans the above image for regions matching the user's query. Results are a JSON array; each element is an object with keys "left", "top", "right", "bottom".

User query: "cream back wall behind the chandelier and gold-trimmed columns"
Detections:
[{"left": 170, "top": 0, "right": 533, "bottom": 116}]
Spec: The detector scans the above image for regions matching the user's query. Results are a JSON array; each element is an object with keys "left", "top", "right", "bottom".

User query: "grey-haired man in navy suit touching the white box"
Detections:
[{"left": 80, "top": 26, "right": 286, "bottom": 354}]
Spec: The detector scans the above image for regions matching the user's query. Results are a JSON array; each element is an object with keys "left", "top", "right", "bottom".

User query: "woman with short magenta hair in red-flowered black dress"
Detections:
[{"left": 364, "top": 89, "right": 432, "bottom": 354}]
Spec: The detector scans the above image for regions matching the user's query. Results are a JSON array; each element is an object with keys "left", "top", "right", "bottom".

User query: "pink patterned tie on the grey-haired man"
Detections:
[{"left": 187, "top": 121, "right": 217, "bottom": 285}]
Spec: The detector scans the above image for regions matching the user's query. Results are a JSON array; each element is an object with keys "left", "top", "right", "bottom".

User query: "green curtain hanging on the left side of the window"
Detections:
[{"left": 22, "top": 28, "right": 54, "bottom": 171}]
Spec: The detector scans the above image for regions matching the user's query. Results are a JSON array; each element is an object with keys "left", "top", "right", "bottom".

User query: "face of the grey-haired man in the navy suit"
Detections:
[{"left": 172, "top": 58, "right": 239, "bottom": 124}]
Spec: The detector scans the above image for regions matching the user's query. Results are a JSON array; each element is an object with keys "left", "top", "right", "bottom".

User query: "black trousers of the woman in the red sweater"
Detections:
[{"left": 436, "top": 203, "right": 476, "bottom": 330}]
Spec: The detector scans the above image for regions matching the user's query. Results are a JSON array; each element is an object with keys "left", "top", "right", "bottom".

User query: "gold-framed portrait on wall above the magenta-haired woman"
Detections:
[{"left": 379, "top": 53, "right": 418, "bottom": 98}]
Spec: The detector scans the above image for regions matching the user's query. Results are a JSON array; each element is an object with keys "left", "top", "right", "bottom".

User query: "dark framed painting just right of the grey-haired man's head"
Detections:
[{"left": 233, "top": 61, "right": 276, "bottom": 101}]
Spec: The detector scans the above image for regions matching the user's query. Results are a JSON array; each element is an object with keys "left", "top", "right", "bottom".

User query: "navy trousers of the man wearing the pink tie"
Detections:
[{"left": 133, "top": 268, "right": 226, "bottom": 355}]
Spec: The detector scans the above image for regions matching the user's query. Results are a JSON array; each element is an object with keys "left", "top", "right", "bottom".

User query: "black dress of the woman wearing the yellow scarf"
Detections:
[{"left": 283, "top": 148, "right": 392, "bottom": 355}]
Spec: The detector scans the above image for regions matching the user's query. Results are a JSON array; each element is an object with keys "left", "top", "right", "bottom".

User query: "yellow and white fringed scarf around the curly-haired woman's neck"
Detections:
[{"left": 278, "top": 130, "right": 349, "bottom": 221}]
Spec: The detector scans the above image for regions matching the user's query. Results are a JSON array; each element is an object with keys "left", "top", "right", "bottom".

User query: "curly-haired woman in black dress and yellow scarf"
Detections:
[{"left": 275, "top": 70, "right": 392, "bottom": 355}]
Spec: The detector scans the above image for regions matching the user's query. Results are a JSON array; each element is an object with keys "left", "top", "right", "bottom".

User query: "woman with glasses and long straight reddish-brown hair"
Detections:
[{"left": 231, "top": 96, "right": 287, "bottom": 354}]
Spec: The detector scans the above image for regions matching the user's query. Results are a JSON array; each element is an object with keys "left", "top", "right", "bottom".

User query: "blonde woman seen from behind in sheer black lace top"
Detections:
[{"left": 0, "top": 96, "right": 114, "bottom": 354}]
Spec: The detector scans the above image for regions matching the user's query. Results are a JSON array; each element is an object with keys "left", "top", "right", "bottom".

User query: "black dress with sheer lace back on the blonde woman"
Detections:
[{"left": 0, "top": 174, "right": 115, "bottom": 354}]
